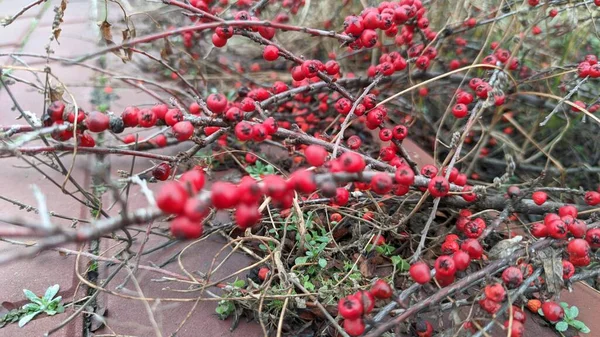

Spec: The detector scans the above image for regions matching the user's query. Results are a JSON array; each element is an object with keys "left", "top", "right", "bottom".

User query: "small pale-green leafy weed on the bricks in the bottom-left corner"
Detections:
[{"left": 0, "top": 284, "right": 65, "bottom": 327}]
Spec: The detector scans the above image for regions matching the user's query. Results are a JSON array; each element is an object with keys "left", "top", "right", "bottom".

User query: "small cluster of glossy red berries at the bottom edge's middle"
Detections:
[{"left": 338, "top": 280, "right": 393, "bottom": 336}]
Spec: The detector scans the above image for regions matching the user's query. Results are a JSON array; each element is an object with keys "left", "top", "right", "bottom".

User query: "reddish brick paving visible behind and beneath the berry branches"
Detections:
[{"left": 0, "top": 0, "right": 600, "bottom": 337}]
